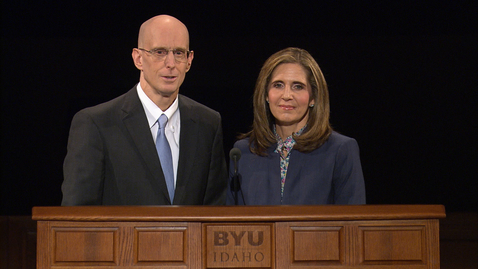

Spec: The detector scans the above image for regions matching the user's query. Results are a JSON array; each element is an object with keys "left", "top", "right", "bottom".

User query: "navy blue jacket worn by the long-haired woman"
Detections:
[{"left": 227, "top": 132, "right": 365, "bottom": 205}]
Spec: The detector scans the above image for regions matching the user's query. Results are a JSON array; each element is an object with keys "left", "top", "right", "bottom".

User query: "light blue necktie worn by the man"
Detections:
[{"left": 156, "top": 114, "right": 174, "bottom": 204}]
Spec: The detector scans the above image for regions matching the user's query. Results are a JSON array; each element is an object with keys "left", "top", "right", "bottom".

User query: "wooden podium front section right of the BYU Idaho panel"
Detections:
[{"left": 275, "top": 220, "right": 439, "bottom": 269}]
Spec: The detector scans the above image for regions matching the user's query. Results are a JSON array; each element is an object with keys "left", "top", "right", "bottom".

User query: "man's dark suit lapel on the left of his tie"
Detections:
[{"left": 122, "top": 87, "right": 169, "bottom": 199}]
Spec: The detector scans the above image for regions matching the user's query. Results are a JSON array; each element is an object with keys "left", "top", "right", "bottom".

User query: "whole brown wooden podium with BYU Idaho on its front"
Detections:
[{"left": 33, "top": 205, "right": 445, "bottom": 269}]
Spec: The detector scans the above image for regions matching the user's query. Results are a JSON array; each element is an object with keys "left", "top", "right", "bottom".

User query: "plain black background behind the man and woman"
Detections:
[{"left": 0, "top": 0, "right": 478, "bottom": 215}]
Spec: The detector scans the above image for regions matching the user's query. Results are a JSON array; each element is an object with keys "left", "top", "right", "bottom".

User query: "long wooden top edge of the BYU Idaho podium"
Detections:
[{"left": 32, "top": 205, "right": 446, "bottom": 222}]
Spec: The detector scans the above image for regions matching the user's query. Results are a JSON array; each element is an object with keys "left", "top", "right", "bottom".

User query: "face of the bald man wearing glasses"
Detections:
[{"left": 134, "top": 21, "right": 193, "bottom": 98}]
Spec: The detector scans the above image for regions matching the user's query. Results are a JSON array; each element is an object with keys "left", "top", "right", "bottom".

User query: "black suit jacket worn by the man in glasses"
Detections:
[{"left": 62, "top": 87, "right": 227, "bottom": 205}]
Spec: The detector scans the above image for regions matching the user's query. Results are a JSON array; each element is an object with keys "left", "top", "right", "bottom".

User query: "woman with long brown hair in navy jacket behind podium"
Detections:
[{"left": 227, "top": 48, "right": 365, "bottom": 205}]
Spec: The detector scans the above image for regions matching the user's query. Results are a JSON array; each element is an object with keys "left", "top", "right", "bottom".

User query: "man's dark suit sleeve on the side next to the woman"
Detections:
[{"left": 203, "top": 116, "right": 228, "bottom": 205}]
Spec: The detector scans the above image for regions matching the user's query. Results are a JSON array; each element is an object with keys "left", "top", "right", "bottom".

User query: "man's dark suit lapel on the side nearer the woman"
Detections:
[{"left": 174, "top": 95, "right": 199, "bottom": 204}]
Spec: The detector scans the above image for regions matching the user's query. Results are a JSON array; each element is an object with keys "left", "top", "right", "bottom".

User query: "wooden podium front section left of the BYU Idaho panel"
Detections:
[{"left": 37, "top": 221, "right": 201, "bottom": 269}]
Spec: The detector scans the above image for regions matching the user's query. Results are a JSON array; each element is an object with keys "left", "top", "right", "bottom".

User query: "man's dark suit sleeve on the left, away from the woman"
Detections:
[{"left": 61, "top": 110, "right": 104, "bottom": 206}]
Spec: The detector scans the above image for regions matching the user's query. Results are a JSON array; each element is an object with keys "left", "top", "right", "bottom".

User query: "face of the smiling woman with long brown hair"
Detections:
[{"left": 266, "top": 63, "right": 314, "bottom": 131}]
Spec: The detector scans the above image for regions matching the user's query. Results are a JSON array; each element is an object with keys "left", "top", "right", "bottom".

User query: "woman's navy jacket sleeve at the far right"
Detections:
[{"left": 333, "top": 139, "right": 365, "bottom": 204}]
